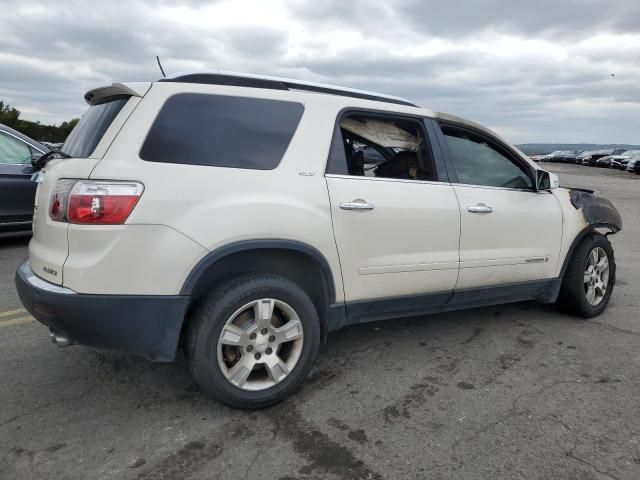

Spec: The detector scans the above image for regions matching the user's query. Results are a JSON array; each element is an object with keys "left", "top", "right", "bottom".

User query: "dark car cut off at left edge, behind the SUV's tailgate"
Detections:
[{"left": 0, "top": 124, "right": 49, "bottom": 232}]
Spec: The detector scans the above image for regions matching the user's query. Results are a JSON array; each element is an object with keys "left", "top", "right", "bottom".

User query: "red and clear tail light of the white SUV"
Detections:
[{"left": 49, "top": 179, "right": 144, "bottom": 225}]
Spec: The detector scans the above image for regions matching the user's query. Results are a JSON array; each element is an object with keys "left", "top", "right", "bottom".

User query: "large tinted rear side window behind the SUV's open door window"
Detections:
[{"left": 140, "top": 93, "right": 304, "bottom": 170}]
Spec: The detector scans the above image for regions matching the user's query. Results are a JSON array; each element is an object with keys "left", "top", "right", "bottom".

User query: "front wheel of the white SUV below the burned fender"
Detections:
[{"left": 556, "top": 232, "right": 616, "bottom": 318}]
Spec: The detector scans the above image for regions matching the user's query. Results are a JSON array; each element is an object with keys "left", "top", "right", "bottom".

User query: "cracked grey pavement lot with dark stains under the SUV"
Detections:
[{"left": 0, "top": 165, "right": 640, "bottom": 480}]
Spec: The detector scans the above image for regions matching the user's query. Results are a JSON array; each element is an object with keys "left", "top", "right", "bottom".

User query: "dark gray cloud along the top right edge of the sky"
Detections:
[{"left": 293, "top": 0, "right": 640, "bottom": 38}]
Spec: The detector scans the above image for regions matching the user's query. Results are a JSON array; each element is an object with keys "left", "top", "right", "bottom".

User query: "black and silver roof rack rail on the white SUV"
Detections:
[{"left": 158, "top": 70, "right": 417, "bottom": 107}]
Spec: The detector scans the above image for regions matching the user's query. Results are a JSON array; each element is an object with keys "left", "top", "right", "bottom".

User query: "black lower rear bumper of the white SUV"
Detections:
[{"left": 16, "top": 262, "right": 189, "bottom": 362}]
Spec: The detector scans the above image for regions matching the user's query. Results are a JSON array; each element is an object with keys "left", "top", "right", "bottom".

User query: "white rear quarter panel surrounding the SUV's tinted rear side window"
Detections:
[{"left": 91, "top": 83, "right": 343, "bottom": 301}]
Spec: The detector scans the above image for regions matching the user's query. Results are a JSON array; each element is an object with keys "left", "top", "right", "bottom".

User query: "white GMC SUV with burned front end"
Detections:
[{"left": 16, "top": 72, "right": 621, "bottom": 408}]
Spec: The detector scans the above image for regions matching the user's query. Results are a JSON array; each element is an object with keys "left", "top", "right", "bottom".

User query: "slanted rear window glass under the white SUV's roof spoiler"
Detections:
[{"left": 61, "top": 96, "right": 130, "bottom": 158}]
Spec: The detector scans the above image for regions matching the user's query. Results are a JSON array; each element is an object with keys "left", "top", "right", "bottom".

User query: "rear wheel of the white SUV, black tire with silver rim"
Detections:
[{"left": 187, "top": 274, "right": 320, "bottom": 409}]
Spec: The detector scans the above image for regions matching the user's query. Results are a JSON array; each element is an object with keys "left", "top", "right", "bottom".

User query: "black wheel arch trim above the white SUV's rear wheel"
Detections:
[{"left": 180, "top": 239, "right": 336, "bottom": 305}]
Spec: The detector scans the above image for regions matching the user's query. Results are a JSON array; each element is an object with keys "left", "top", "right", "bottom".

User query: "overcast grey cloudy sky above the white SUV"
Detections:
[{"left": 0, "top": 0, "right": 640, "bottom": 143}]
